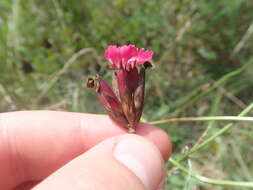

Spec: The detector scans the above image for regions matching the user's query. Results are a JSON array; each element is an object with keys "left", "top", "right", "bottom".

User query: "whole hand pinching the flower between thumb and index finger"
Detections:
[{"left": 0, "top": 111, "right": 171, "bottom": 190}]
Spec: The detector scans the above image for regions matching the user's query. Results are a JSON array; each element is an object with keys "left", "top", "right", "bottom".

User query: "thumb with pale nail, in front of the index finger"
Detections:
[{"left": 34, "top": 134, "right": 165, "bottom": 190}]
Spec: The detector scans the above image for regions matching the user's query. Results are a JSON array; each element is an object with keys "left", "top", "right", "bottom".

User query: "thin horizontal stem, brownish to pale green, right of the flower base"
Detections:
[{"left": 149, "top": 116, "right": 253, "bottom": 125}]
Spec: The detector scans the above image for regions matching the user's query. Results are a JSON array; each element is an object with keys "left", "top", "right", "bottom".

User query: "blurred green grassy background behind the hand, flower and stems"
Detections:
[{"left": 0, "top": 0, "right": 253, "bottom": 190}]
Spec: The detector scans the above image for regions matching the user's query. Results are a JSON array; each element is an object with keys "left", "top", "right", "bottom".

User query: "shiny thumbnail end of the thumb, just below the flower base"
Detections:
[{"left": 113, "top": 134, "right": 165, "bottom": 190}]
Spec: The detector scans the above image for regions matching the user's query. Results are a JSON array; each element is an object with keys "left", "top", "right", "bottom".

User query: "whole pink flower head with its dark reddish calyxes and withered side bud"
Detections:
[{"left": 87, "top": 45, "right": 153, "bottom": 132}]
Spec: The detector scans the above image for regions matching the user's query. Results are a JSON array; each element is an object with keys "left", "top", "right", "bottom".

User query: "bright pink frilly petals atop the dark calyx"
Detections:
[{"left": 105, "top": 45, "right": 153, "bottom": 69}]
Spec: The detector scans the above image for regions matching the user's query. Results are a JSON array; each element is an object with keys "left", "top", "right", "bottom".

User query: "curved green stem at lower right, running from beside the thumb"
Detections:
[{"left": 169, "top": 158, "right": 253, "bottom": 188}]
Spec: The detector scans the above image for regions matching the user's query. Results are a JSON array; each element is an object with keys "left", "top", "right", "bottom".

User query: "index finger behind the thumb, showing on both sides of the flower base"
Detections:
[{"left": 0, "top": 111, "right": 171, "bottom": 189}]
